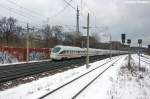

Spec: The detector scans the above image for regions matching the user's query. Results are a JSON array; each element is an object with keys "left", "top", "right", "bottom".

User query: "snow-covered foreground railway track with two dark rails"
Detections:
[{"left": 38, "top": 57, "right": 120, "bottom": 99}]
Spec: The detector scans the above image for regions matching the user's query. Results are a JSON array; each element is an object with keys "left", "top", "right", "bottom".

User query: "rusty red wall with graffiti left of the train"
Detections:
[{"left": 0, "top": 47, "right": 51, "bottom": 62}]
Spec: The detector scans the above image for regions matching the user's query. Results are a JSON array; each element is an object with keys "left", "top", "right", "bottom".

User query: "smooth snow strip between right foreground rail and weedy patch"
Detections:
[{"left": 77, "top": 54, "right": 125, "bottom": 99}]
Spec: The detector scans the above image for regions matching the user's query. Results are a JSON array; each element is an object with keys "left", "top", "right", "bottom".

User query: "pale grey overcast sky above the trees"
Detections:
[{"left": 0, "top": 0, "right": 150, "bottom": 46}]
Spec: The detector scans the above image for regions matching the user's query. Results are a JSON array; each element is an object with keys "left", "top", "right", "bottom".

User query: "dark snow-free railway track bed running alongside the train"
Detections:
[{"left": 0, "top": 55, "right": 119, "bottom": 83}]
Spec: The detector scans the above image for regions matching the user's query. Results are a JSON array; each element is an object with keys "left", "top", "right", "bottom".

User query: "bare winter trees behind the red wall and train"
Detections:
[{"left": 0, "top": 17, "right": 103, "bottom": 48}]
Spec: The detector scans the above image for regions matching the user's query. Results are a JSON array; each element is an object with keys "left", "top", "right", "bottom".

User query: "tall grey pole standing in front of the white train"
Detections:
[{"left": 86, "top": 13, "right": 89, "bottom": 68}]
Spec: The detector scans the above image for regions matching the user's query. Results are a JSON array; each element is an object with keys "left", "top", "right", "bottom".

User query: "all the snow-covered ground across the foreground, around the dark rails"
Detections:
[{"left": 0, "top": 55, "right": 150, "bottom": 99}]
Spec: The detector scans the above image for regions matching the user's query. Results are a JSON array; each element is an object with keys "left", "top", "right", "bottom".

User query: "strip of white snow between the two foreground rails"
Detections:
[{"left": 44, "top": 58, "right": 122, "bottom": 99}]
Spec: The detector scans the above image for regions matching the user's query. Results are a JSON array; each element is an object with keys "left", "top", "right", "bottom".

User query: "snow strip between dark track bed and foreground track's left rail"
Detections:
[{"left": 0, "top": 55, "right": 117, "bottom": 99}]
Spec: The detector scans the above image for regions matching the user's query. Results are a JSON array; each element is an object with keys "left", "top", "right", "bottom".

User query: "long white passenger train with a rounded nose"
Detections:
[{"left": 50, "top": 45, "right": 126, "bottom": 60}]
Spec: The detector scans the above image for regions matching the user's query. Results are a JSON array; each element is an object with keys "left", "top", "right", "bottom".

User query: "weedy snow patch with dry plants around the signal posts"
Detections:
[{"left": 107, "top": 55, "right": 150, "bottom": 99}]
